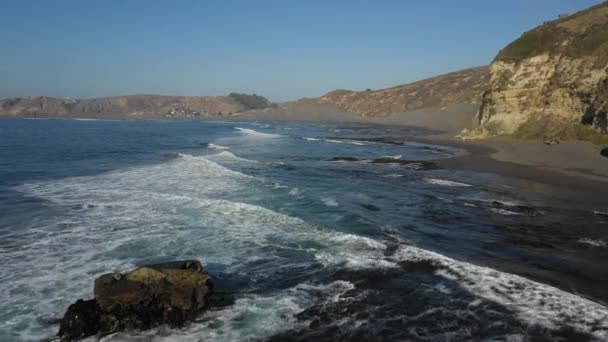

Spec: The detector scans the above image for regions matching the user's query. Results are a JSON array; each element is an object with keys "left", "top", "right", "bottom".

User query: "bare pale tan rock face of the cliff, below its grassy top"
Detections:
[{"left": 468, "top": 54, "right": 608, "bottom": 138}]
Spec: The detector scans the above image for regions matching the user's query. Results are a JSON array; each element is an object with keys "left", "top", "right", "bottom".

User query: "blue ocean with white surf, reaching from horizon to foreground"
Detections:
[{"left": 0, "top": 119, "right": 608, "bottom": 341}]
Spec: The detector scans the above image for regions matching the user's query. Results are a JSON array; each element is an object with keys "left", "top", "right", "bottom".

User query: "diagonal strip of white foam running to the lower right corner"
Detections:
[{"left": 395, "top": 246, "right": 608, "bottom": 340}]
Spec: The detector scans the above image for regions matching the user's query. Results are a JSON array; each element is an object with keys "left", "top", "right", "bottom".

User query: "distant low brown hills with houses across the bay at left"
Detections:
[{"left": 0, "top": 93, "right": 274, "bottom": 118}]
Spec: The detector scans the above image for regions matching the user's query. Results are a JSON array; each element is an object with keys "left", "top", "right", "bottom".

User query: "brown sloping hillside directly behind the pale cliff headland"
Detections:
[{"left": 318, "top": 66, "right": 489, "bottom": 117}]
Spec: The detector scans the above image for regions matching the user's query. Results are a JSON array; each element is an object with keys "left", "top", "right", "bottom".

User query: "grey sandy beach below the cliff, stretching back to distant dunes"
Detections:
[{"left": 239, "top": 101, "right": 608, "bottom": 206}]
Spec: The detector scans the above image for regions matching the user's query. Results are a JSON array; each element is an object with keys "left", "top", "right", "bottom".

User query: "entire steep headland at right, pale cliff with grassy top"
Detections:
[{"left": 462, "top": 3, "right": 608, "bottom": 143}]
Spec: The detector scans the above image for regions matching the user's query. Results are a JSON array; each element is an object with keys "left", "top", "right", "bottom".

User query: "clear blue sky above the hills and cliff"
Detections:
[{"left": 0, "top": 0, "right": 601, "bottom": 101}]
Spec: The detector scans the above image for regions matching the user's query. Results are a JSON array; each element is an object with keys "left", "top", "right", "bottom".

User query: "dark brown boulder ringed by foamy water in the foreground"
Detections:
[{"left": 58, "top": 260, "right": 211, "bottom": 340}]
